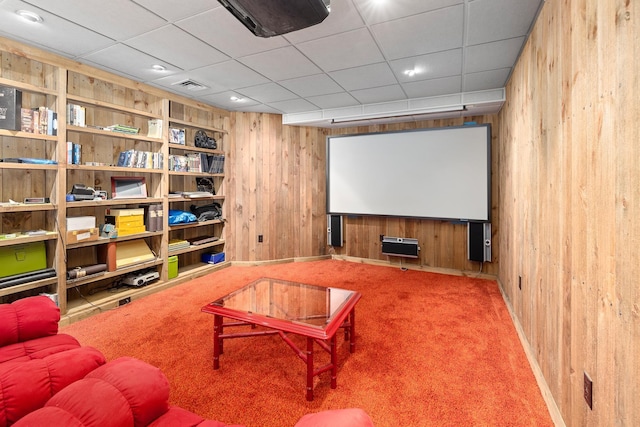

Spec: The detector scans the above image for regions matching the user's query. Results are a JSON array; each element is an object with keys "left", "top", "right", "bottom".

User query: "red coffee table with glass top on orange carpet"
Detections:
[{"left": 202, "top": 278, "right": 362, "bottom": 400}]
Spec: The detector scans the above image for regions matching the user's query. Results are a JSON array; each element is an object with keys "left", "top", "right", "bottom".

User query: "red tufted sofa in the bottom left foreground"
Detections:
[{"left": 0, "top": 296, "right": 373, "bottom": 427}]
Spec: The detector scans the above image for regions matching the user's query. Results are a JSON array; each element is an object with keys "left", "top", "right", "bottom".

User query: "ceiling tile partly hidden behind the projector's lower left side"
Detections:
[{"left": 176, "top": 7, "right": 289, "bottom": 58}]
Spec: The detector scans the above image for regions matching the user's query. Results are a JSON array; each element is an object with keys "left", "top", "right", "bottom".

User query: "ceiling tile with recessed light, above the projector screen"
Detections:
[{"left": 390, "top": 49, "right": 462, "bottom": 83}]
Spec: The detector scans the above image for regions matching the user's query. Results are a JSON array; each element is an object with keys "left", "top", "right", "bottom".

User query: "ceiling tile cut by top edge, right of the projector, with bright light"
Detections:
[{"left": 352, "top": 0, "right": 464, "bottom": 25}]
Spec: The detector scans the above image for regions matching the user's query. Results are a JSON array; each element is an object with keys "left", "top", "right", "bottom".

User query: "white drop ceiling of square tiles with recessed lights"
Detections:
[{"left": 0, "top": 0, "right": 544, "bottom": 126}]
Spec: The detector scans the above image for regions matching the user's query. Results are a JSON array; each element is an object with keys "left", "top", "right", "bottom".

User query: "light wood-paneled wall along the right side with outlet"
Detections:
[{"left": 497, "top": 0, "right": 640, "bottom": 426}]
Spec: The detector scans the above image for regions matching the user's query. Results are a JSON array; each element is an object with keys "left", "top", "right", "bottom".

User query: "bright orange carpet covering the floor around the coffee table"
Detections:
[{"left": 62, "top": 260, "right": 553, "bottom": 427}]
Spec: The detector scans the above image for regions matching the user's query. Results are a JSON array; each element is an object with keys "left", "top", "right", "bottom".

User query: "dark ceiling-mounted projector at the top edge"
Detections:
[{"left": 218, "top": 0, "right": 330, "bottom": 37}]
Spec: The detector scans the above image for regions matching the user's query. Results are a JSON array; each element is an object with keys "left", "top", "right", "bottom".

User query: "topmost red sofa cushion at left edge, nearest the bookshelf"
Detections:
[{"left": 0, "top": 296, "right": 60, "bottom": 347}]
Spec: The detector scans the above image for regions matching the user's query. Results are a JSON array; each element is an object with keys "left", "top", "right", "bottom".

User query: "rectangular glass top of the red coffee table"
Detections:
[{"left": 209, "top": 278, "right": 360, "bottom": 328}]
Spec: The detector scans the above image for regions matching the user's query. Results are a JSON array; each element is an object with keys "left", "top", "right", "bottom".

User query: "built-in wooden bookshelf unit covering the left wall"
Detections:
[{"left": 0, "top": 38, "right": 230, "bottom": 319}]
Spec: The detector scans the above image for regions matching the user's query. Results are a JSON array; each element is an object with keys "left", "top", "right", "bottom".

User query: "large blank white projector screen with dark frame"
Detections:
[{"left": 327, "top": 124, "right": 491, "bottom": 221}]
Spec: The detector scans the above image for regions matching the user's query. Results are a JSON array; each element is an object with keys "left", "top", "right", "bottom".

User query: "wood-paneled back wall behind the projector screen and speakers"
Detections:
[{"left": 225, "top": 113, "right": 500, "bottom": 274}]
